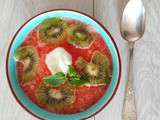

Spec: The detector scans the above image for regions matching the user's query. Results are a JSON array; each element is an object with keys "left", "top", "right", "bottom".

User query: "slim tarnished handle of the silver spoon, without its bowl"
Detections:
[{"left": 122, "top": 42, "right": 137, "bottom": 120}]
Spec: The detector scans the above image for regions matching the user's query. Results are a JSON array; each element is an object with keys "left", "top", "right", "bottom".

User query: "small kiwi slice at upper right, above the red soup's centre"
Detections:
[{"left": 68, "top": 25, "right": 93, "bottom": 48}]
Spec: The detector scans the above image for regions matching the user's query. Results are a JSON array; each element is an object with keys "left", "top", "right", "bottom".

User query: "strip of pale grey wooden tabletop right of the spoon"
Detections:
[{"left": 133, "top": 0, "right": 160, "bottom": 120}]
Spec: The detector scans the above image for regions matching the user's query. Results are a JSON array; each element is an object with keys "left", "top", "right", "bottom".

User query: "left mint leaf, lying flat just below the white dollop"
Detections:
[{"left": 44, "top": 72, "right": 67, "bottom": 87}]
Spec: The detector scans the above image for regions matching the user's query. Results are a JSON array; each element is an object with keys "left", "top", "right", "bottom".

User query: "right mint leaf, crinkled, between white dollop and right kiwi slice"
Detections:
[{"left": 67, "top": 65, "right": 84, "bottom": 86}]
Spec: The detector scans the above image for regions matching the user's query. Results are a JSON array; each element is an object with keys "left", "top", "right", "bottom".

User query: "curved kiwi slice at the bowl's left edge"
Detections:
[{"left": 14, "top": 46, "right": 39, "bottom": 83}]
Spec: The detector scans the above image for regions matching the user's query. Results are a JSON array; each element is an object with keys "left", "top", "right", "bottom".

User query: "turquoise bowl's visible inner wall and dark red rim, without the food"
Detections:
[{"left": 6, "top": 10, "right": 121, "bottom": 120}]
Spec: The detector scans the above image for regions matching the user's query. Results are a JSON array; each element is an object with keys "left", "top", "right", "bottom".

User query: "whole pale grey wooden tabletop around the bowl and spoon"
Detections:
[{"left": 0, "top": 0, "right": 160, "bottom": 120}]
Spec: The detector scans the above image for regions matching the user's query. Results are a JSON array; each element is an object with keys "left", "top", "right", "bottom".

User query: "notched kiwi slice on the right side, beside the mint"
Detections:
[{"left": 76, "top": 52, "right": 111, "bottom": 85}]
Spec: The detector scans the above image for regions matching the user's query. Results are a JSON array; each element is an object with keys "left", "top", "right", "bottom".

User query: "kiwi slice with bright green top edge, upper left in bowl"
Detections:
[{"left": 38, "top": 18, "right": 67, "bottom": 44}]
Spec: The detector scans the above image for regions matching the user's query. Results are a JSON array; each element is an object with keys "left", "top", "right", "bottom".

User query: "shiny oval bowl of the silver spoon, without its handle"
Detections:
[{"left": 120, "top": 0, "right": 145, "bottom": 42}]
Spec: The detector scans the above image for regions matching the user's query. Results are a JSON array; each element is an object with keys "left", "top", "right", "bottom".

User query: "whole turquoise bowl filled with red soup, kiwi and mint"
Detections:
[{"left": 6, "top": 10, "right": 121, "bottom": 120}]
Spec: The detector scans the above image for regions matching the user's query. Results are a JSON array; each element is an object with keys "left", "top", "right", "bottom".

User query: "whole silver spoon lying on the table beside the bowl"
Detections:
[{"left": 120, "top": 0, "right": 146, "bottom": 120}]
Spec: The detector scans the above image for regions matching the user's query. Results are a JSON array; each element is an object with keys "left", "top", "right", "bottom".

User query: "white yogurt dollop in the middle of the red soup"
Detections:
[{"left": 45, "top": 47, "right": 72, "bottom": 74}]
